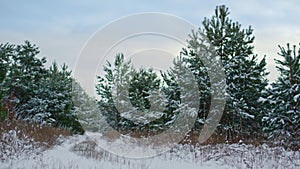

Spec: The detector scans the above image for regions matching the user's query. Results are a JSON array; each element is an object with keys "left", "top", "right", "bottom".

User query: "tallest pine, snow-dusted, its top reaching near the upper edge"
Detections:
[{"left": 185, "top": 6, "right": 267, "bottom": 138}]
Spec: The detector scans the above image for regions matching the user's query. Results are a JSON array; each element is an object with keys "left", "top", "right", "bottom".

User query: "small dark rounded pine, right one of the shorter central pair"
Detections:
[{"left": 129, "top": 68, "right": 164, "bottom": 124}]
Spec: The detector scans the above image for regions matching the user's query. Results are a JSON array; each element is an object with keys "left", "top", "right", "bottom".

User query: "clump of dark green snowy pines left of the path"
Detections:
[{"left": 0, "top": 41, "right": 83, "bottom": 133}]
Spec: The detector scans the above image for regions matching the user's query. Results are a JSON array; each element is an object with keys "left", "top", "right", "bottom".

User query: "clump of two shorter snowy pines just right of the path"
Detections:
[{"left": 96, "top": 54, "right": 170, "bottom": 133}]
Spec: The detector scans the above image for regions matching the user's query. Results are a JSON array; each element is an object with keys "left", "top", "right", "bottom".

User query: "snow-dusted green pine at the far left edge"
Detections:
[{"left": 1, "top": 41, "right": 46, "bottom": 118}]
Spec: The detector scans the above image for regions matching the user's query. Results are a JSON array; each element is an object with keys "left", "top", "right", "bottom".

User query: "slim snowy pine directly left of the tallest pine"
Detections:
[{"left": 163, "top": 55, "right": 200, "bottom": 134}]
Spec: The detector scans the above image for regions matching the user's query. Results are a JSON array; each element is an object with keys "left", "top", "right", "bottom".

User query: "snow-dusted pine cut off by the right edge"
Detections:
[{"left": 264, "top": 44, "right": 300, "bottom": 146}]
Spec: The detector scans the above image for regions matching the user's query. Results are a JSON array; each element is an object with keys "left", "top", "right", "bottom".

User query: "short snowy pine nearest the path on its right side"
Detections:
[{"left": 96, "top": 54, "right": 132, "bottom": 130}]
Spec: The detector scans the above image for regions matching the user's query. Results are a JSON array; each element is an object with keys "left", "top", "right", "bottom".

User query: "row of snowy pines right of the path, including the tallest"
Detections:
[{"left": 96, "top": 6, "right": 300, "bottom": 146}]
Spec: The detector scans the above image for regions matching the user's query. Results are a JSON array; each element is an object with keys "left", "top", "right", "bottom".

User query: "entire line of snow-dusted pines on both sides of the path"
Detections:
[{"left": 0, "top": 6, "right": 300, "bottom": 146}]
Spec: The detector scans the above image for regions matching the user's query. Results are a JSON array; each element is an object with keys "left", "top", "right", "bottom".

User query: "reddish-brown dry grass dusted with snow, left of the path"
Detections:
[{"left": 0, "top": 120, "right": 70, "bottom": 161}]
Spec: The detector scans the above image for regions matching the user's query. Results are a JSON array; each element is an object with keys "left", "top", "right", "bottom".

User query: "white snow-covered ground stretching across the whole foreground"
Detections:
[{"left": 0, "top": 136, "right": 300, "bottom": 169}]
